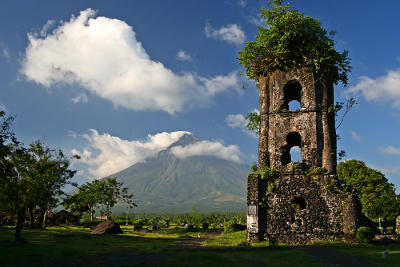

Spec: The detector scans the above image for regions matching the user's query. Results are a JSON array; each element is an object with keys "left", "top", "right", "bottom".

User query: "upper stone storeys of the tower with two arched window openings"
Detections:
[{"left": 258, "top": 68, "right": 336, "bottom": 172}]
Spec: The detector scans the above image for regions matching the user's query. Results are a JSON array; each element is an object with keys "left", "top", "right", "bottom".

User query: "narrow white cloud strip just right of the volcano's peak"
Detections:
[{"left": 171, "top": 141, "right": 241, "bottom": 163}]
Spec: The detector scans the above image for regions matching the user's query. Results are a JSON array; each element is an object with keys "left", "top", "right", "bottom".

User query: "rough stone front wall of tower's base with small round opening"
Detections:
[{"left": 267, "top": 163, "right": 345, "bottom": 244}]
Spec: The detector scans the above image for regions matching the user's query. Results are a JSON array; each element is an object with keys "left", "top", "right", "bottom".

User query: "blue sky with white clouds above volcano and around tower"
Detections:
[{"left": 0, "top": 0, "right": 400, "bottom": 192}]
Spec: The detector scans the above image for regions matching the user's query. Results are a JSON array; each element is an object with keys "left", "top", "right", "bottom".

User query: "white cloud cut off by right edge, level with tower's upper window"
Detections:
[{"left": 344, "top": 70, "right": 400, "bottom": 109}]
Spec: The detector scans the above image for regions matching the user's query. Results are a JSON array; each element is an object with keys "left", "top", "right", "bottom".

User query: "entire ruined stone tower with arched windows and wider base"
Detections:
[{"left": 247, "top": 68, "right": 357, "bottom": 244}]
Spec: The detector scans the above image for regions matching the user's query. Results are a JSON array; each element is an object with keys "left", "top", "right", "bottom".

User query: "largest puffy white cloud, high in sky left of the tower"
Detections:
[{"left": 20, "top": 9, "right": 243, "bottom": 114}]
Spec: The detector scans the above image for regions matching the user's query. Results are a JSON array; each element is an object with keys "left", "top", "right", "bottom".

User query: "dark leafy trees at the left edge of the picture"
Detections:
[{"left": 0, "top": 111, "right": 75, "bottom": 242}]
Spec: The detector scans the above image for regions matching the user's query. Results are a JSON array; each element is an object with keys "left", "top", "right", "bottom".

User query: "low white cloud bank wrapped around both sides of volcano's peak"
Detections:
[{"left": 71, "top": 129, "right": 241, "bottom": 179}]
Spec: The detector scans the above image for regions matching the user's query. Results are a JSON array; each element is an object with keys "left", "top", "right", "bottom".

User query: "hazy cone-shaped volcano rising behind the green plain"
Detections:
[{"left": 111, "top": 135, "right": 250, "bottom": 212}]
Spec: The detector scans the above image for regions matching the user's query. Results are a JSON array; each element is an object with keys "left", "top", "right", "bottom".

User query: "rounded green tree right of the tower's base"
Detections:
[{"left": 337, "top": 160, "right": 400, "bottom": 220}]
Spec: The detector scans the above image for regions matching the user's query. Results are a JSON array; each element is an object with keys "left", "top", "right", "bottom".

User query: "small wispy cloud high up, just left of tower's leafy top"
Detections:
[{"left": 204, "top": 23, "right": 246, "bottom": 45}]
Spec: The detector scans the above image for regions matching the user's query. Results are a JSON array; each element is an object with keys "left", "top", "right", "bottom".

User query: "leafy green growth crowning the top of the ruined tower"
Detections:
[{"left": 238, "top": 0, "right": 351, "bottom": 85}]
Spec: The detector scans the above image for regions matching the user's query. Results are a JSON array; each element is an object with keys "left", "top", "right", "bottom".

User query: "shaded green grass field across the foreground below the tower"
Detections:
[{"left": 0, "top": 226, "right": 400, "bottom": 267}]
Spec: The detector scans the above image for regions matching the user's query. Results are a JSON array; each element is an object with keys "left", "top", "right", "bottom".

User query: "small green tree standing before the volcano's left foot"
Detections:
[{"left": 64, "top": 178, "right": 136, "bottom": 220}]
